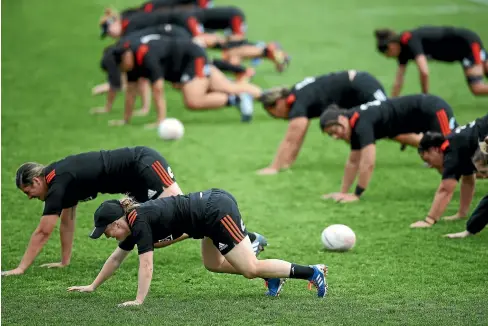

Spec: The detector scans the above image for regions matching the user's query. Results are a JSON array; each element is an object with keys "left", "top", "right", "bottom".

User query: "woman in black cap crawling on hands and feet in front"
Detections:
[{"left": 68, "top": 189, "right": 327, "bottom": 306}]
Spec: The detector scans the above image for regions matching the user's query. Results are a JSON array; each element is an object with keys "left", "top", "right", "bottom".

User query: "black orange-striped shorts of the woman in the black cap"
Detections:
[{"left": 205, "top": 189, "right": 248, "bottom": 255}]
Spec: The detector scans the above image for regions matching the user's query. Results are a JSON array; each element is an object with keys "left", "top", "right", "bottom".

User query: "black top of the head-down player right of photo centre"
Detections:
[{"left": 286, "top": 71, "right": 368, "bottom": 120}]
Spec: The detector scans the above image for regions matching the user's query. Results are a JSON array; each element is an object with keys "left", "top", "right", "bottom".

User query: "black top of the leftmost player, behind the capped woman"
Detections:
[{"left": 43, "top": 146, "right": 158, "bottom": 215}]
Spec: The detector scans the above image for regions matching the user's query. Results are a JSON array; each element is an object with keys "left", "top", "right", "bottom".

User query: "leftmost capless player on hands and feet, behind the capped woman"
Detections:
[{"left": 2, "top": 146, "right": 266, "bottom": 275}]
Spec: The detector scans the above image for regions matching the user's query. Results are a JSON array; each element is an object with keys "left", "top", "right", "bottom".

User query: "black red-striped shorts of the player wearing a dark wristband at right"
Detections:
[{"left": 421, "top": 96, "right": 458, "bottom": 136}]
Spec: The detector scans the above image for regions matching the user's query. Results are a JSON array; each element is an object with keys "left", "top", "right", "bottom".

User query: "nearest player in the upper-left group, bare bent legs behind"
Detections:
[{"left": 104, "top": 38, "right": 261, "bottom": 126}]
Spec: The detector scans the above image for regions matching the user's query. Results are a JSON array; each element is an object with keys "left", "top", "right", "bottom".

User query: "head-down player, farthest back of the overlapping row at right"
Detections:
[{"left": 258, "top": 70, "right": 386, "bottom": 175}]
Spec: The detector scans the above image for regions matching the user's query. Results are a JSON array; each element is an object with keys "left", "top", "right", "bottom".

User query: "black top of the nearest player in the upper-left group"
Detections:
[{"left": 124, "top": 37, "right": 206, "bottom": 83}]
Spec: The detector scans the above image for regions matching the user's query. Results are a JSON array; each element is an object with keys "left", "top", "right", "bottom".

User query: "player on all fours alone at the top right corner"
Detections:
[{"left": 375, "top": 26, "right": 488, "bottom": 97}]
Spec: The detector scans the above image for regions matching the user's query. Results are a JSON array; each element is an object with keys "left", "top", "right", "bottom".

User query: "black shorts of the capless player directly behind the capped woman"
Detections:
[{"left": 129, "top": 146, "right": 176, "bottom": 203}]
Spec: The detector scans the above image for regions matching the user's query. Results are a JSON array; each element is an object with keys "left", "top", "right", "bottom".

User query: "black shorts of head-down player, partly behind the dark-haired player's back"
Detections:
[{"left": 351, "top": 71, "right": 387, "bottom": 106}]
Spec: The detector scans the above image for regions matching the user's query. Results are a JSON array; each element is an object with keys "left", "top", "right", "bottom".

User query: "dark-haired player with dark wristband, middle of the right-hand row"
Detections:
[{"left": 320, "top": 94, "right": 456, "bottom": 202}]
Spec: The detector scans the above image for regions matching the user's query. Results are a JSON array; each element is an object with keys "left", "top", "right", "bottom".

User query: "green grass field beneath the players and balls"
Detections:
[{"left": 1, "top": 0, "right": 488, "bottom": 325}]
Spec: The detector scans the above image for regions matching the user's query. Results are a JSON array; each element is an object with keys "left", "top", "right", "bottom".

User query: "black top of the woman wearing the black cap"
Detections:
[{"left": 119, "top": 190, "right": 211, "bottom": 255}]
